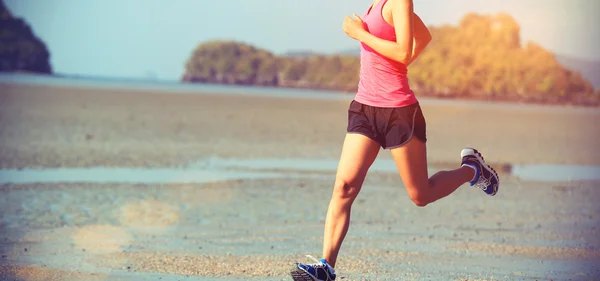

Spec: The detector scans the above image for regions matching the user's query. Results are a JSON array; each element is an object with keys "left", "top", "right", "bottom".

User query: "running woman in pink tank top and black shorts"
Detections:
[{"left": 291, "top": 0, "right": 499, "bottom": 280}]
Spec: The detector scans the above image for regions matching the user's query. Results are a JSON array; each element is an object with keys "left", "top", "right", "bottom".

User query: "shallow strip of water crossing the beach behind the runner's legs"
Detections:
[{"left": 0, "top": 155, "right": 600, "bottom": 184}]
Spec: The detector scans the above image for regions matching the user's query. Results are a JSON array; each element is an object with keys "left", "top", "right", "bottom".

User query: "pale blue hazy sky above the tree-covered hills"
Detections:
[{"left": 4, "top": 0, "right": 600, "bottom": 81}]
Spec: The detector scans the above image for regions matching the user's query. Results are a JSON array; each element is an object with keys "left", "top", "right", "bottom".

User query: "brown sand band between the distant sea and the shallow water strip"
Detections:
[{"left": 0, "top": 84, "right": 600, "bottom": 168}]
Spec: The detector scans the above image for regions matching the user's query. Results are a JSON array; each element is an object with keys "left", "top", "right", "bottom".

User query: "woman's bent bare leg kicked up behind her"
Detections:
[{"left": 391, "top": 137, "right": 475, "bottom": 207}]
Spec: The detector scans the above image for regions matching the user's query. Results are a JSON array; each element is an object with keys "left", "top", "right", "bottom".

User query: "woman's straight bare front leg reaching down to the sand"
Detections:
[{"left": 323, "top": 134, "right": 380, "bottom": 267}]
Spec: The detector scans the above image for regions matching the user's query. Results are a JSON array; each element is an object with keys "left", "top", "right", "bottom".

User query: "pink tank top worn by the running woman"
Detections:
[{"left": 354, "top": 0, "right": 417, "bottom": 107}]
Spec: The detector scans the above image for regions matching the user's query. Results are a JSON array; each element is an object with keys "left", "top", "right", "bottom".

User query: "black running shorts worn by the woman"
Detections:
[{"left": 347, "top": 100, "right": 427, "bottom": 149}]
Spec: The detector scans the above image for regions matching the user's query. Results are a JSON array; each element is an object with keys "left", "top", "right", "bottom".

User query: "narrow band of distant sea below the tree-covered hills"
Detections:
[{"left": 0, "top": 72, "right": 600, "bottom": 111}]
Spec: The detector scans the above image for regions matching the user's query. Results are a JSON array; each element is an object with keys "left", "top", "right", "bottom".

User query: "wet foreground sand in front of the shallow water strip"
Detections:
[{"left": 0, "top": 174, "right": 600, "bottom": 280}]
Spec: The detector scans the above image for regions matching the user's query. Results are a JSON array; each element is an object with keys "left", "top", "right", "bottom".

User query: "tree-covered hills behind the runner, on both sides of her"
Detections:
[{"left": 182, "top": 14, "right": 600, "bottom": 105}]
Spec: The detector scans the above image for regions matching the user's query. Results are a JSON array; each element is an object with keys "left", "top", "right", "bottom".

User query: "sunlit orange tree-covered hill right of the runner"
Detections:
[{"left": 409, "top": 14, "right": 598, "bottom": 103}]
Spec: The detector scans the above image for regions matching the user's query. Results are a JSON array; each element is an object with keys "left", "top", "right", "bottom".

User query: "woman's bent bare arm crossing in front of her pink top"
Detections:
[{"left": 344, "top": 0, "right": 414, "bottom": 65}]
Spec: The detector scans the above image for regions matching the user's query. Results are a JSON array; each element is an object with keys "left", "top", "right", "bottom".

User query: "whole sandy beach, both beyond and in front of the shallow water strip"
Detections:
[{"left": 0, "top": 82, "right": 600, "bottom": 280}]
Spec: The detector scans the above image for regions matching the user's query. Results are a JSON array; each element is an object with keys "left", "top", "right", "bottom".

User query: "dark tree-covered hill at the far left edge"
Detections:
[{"left": 0, "top": 0, "right": 52, "bottom": 74}]
